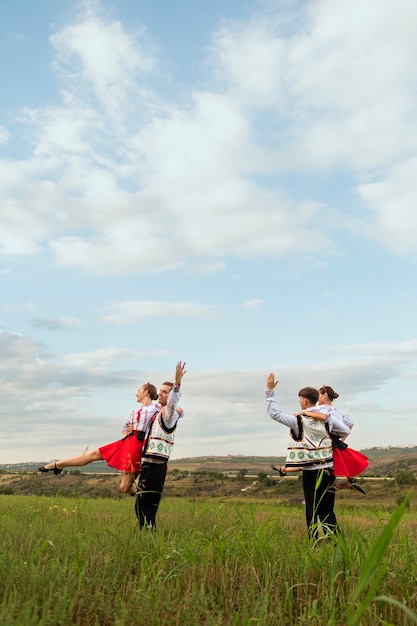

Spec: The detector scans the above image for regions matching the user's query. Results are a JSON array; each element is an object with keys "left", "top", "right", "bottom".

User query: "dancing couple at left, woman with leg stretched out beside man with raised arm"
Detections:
[{"left": 39, "top": 361, "right": 186, "bottom": 527}]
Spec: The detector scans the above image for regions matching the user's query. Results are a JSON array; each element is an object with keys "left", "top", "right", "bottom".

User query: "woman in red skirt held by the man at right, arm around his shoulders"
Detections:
[{"left": 272, "top": 385, "right": 369, "bottom": 494}]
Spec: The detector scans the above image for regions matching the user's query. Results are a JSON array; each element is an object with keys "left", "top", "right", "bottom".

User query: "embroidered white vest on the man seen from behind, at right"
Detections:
[{"left": 285, "top": 415, "right": 333, "bottom": 467}]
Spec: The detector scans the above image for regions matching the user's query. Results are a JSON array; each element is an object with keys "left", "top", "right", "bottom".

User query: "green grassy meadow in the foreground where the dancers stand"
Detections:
[{"left": 0, "top": 495, "right": 417, "bottom": 626}]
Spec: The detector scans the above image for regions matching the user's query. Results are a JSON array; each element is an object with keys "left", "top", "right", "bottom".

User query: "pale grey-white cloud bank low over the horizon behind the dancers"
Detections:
[{"left": 0, "top": 322, "right": 417, "bottom": 462}]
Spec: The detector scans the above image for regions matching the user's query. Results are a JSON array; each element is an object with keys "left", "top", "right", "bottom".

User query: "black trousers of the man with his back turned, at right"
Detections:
[{"left": 303, "top": 468, "right": 337, "bottom": 538}]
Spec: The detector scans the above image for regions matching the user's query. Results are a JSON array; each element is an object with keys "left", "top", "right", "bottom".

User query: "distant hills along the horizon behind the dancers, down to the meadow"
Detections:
[{"left": 0, "top": 446, "right": 417, "bottom": 505}]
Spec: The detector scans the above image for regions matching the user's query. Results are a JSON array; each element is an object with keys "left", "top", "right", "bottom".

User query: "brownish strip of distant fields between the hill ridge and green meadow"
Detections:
[{"left": 0, "top": 464, "right": 417, "bottom": 507}]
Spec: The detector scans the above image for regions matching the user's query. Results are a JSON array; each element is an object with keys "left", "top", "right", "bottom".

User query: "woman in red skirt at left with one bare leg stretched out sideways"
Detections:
[{"left": 39, "top": 383, "right": 161, "bottom": 493}]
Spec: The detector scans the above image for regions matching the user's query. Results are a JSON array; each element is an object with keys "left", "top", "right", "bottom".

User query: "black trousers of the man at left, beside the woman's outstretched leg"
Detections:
[{"left": 135, "top": 462, "right": 167, "bottom": 528}]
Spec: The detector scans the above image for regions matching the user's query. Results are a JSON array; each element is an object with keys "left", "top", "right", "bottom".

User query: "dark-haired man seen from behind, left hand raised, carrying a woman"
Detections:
[{"left": 266, "top": 373, "right": 350, "bottom": 538}]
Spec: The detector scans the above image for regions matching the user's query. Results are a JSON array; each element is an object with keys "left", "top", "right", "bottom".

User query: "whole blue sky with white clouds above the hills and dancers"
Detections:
[{"left": 0, "top": 0, "right": 417, "bottom": 463}]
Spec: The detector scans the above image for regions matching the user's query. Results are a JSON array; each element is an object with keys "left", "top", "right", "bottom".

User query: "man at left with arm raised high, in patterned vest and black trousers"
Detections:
[{"left": 135, "top": 361, "right": 186, "bottom": 528}]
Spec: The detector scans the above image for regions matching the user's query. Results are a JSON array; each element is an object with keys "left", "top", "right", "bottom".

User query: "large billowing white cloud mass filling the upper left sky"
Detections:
[{"left": 0, "top": 3, "right": 331, "bottom": 273}]
